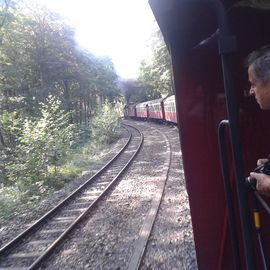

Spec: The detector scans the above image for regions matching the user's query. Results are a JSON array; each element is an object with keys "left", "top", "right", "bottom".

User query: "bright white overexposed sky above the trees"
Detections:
[{"left": 39, "top": 0, "right": 157, "bottom": 79}]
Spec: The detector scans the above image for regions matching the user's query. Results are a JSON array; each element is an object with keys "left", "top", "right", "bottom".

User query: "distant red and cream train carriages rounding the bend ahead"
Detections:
[{"left": 124, "top": 95, "right": 177, "bottom": 124}]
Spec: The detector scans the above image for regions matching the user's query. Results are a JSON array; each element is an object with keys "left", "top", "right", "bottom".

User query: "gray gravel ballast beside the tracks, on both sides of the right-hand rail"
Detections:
[{"left": 0, "top": 121, "right": 197, "bottom": 269}]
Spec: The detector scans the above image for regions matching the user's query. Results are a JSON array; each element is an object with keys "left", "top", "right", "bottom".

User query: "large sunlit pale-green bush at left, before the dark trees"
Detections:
[{"left": 6, "top": 96, "right": 74, "bottom": 187}]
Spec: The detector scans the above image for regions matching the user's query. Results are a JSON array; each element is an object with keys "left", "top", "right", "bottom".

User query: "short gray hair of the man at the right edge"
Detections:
[{"left": 246, "top": 46, "right": 270, "bottom": 84}]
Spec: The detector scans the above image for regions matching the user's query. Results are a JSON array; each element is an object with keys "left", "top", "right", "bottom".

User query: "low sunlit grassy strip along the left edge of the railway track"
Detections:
[{"left": 0, "top": 136, "right": 120, "bottom": 226}]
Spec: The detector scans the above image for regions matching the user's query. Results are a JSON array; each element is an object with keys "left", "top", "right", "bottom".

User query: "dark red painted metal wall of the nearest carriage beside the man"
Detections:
[{"left": 150, "top": 0, "right": 270, "bottom": 270}]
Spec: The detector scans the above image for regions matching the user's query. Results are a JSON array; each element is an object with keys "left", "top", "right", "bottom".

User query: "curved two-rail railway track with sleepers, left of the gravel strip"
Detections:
[{"left": 0, "top": 125, "right": 143, "bottom": 269}]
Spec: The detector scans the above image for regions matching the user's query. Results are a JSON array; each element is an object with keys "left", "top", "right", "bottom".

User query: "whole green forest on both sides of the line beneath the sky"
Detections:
[{"left": 0, "top": 0, "right": 172, "bottom": 225}]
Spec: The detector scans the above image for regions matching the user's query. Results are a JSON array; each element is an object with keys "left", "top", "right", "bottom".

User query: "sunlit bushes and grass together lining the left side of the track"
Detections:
[{"left": 0, "top": 100, "right": 121, "bottom": 224}]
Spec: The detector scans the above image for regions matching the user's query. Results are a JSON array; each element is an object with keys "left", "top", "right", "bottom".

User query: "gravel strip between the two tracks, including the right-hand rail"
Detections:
[{"left": 43, "top": 121, "right": 175, "bottom": 270}]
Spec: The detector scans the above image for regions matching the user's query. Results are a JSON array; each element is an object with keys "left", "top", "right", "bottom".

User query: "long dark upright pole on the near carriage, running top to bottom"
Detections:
[{"left": 210, "top": 0, "right": 256, "bottom": 270}]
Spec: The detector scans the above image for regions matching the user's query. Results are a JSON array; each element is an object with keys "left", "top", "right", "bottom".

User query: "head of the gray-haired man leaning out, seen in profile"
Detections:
[{"left": 247, "top": 46, "right": 270, "bottom": 110}]
